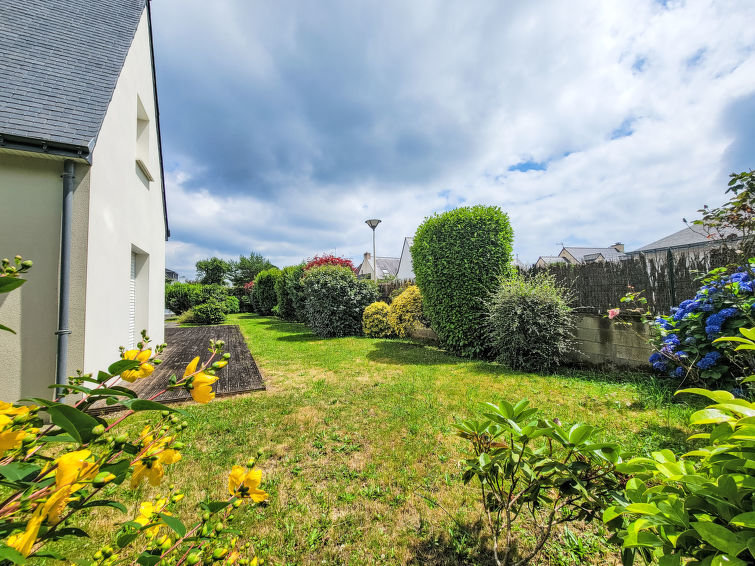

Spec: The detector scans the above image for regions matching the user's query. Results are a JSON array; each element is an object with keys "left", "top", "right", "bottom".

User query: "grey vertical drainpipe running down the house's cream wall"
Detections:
[{"left": 55, "top": 159, "right": 74, "bottom": 397}]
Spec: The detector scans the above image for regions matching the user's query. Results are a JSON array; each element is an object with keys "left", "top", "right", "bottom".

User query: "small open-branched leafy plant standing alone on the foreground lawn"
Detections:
[{"left": 455, "top": 400, "right": 620, "bottom": 566}]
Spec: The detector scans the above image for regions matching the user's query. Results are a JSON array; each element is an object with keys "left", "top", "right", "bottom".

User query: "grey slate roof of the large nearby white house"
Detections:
[{"left": 0, "top": 0, "right": 146, "bottom": 151}]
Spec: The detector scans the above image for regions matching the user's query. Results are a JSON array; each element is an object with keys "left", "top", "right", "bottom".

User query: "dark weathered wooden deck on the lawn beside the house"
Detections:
[{"left": 92, "top": 325, "right": 265, "bottom": 412}]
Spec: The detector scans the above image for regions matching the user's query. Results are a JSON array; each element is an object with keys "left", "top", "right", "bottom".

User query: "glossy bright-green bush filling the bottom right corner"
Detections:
[{"left": 603, "top": 388, "right": 755, "bottom": 566}]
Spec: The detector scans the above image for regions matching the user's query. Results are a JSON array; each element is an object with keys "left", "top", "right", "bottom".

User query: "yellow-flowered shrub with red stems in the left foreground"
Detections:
[{"left": 0, "top": 256, "right": 268, "bottom": 566}]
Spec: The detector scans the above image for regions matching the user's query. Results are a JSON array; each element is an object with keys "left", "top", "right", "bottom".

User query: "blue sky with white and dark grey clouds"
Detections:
[{"left": 152, "top": 0, "right": 755, "bottom": 278}]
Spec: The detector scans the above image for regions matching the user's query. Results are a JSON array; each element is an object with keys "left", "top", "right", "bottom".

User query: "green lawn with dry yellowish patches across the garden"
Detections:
[{"left": 57, "top": 314, "right": 689, "bottom": 565}]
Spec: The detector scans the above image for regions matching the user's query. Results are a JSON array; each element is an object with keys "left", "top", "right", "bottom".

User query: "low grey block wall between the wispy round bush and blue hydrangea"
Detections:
[{"left": 572, "top": 313, "right": 653, "bottom": 368}]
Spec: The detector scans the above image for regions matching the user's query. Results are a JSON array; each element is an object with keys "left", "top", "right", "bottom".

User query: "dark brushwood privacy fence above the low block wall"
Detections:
[{"left": 524, "top": 248, "right": 741, "bottom": 314}]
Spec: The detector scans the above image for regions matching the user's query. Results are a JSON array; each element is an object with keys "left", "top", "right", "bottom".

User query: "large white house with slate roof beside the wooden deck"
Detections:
[{"left": 0, "top": 0, "right": 169, "bottom": 401}]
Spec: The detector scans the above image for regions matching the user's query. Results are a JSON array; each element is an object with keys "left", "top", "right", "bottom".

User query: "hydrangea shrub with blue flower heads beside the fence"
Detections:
[{"left": 650, "top": 262, "right": 755, "bottom": 383}]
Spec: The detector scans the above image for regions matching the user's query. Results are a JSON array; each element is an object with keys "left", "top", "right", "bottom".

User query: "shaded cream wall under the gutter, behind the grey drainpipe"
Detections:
[{"left": 0, "top": 151, "right": 89, "bottom": 401}]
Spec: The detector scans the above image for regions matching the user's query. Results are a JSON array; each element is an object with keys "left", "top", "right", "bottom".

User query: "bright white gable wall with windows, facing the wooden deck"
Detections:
[{"left": 84, "top": 7, "right": 165, "bottom": 378}]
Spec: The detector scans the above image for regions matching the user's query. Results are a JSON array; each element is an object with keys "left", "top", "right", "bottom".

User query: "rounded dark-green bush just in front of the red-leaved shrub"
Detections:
[{"left": 303, "top": 265, "right": 378, "bottom": 337}]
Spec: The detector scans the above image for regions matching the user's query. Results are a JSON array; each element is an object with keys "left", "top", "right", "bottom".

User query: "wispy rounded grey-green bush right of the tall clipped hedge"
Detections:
[{"left": 487, "top": 272, "right": 574, "bottom": 371}]
